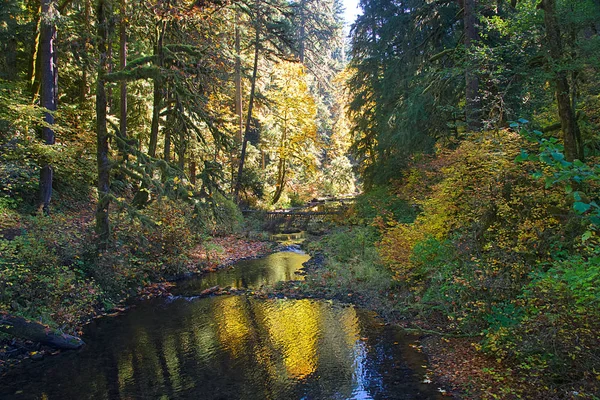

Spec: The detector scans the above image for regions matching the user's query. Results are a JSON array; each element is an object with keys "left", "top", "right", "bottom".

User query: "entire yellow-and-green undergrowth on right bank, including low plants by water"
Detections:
[{"left": 311, "top": 127, "right": 600, "bottom": 399}]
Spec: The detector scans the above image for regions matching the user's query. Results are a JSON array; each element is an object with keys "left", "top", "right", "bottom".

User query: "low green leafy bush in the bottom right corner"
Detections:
[{"left": 483, "top": 255, "right": 600, "bottom": 381}]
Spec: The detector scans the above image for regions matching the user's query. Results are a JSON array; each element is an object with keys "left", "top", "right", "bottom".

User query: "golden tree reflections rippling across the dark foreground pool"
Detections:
[{"left": 108, "top": 296, "right": 368, "bottom": 398}]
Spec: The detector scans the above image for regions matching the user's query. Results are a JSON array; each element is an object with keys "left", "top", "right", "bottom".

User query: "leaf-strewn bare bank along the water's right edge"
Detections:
[{"left": 243, "top": 234, "right": 551, "bottom": 400}]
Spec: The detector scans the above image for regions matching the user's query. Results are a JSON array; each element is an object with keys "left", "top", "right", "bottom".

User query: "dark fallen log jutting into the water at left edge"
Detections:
[{"left": 0, "top": 312, "right": 85, "bottom": 349}]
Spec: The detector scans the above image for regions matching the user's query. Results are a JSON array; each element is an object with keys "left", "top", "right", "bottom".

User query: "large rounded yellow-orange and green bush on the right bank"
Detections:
[{"left": 378, "top": 131, "right": 600, "bottom": 392}]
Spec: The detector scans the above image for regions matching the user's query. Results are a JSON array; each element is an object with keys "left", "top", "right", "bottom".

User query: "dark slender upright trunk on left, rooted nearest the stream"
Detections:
[{"left": 96, "top": 0, "right": 111, "bottom": 250}]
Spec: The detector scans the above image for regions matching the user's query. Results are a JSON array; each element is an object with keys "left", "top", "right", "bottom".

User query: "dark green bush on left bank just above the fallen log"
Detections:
[{"left": 0, "top": 215, "right": 100, "bottom": 328}]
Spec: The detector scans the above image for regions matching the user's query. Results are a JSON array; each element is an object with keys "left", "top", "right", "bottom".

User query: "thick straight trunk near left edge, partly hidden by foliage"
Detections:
[{"left": 39, "top": 0, "right": 58, "bottom": 214}]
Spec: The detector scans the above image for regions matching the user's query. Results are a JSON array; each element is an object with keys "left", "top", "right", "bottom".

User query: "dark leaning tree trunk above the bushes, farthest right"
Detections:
[{"left": 541, "top": 0, "right": 583, "bottom": 161}]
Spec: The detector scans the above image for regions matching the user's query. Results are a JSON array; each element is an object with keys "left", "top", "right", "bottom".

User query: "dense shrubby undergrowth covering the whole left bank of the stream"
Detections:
[{"left": 0, "top": 132, "right": 243, "bottom": 332}]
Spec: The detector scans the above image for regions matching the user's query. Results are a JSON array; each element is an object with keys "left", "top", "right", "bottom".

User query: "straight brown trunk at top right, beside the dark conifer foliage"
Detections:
[{"left": 463, "top": 0, "right": 481, "bottom": 131}]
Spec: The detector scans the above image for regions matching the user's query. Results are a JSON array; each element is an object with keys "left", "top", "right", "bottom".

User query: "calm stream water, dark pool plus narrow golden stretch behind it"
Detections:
[{"left": 0, "top": 252, "right": 439, "bottom": 400}]
